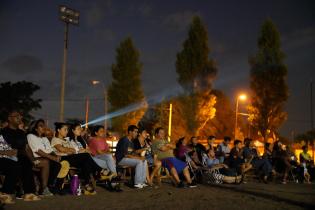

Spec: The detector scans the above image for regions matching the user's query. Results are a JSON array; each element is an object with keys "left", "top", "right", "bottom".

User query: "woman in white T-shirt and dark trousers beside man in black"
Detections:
[{"left": 27, "top": 119, "right": 61, "bottom": 196}]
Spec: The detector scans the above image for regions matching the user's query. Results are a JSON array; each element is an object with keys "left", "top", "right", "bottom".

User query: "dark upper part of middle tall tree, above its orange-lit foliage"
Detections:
[{"left": 176, "top": 16, "right": 217, "bottom": 93}]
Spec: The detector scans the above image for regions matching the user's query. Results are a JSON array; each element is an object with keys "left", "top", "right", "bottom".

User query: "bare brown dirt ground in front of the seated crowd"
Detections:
[{"left": 4, "top": 182, "right": 315, "bottom": 210}]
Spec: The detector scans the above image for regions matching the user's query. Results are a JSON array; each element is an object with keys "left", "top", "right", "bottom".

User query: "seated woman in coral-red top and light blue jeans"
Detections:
[{"left": 87, "top": 125, "right": 117, "bottom": 178}]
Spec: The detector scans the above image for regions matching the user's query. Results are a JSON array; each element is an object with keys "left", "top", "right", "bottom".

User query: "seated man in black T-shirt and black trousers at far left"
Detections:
[{"left": 0, "top": 110, "right": 41, "bottom": 203}]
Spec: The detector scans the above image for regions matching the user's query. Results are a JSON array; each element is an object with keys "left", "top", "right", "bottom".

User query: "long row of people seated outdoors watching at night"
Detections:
[{"left": 0, "top": 111, "right": 314, "bottom": 207}]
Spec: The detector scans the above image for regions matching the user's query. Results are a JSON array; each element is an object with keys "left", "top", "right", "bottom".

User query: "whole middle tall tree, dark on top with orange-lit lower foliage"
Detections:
[{"left": 176, "top": 16, "right": 217, "bottom": 135}]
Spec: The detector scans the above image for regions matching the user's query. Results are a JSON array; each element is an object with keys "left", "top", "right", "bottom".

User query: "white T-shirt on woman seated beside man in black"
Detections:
[{"left": 27, "top": 134, "right": 53, "bottom": 158}]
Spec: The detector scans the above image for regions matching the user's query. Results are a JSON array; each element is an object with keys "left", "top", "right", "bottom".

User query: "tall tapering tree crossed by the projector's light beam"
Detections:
[{"left": 108, "top": 37, "right": 144, "bottom": 132}]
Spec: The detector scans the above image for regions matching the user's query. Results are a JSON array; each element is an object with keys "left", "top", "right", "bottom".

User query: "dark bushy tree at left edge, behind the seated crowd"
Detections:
[{"left": 0, "top": 81, "right": 42, "bottom": 122}]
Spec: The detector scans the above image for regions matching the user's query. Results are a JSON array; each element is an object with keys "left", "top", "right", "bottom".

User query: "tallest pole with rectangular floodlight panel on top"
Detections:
[{"left": 59, "top": 5, "right": 80, "bottom": 122}]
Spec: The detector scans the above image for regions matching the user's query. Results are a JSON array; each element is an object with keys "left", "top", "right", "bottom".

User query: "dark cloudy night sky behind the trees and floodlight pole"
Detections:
[{"left": 0, "top": 0, "right": 315, "bottom": 136}]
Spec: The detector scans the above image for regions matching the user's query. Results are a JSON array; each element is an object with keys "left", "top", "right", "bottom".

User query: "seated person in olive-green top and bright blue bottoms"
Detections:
[{"left": 152, "top": 127, "right": 196, "bottom": 187}]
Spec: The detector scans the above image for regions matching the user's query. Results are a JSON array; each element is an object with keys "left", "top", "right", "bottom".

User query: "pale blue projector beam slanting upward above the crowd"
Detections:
[{"left": 81, "top": 86, "right": 182, "bottom": 127}]
